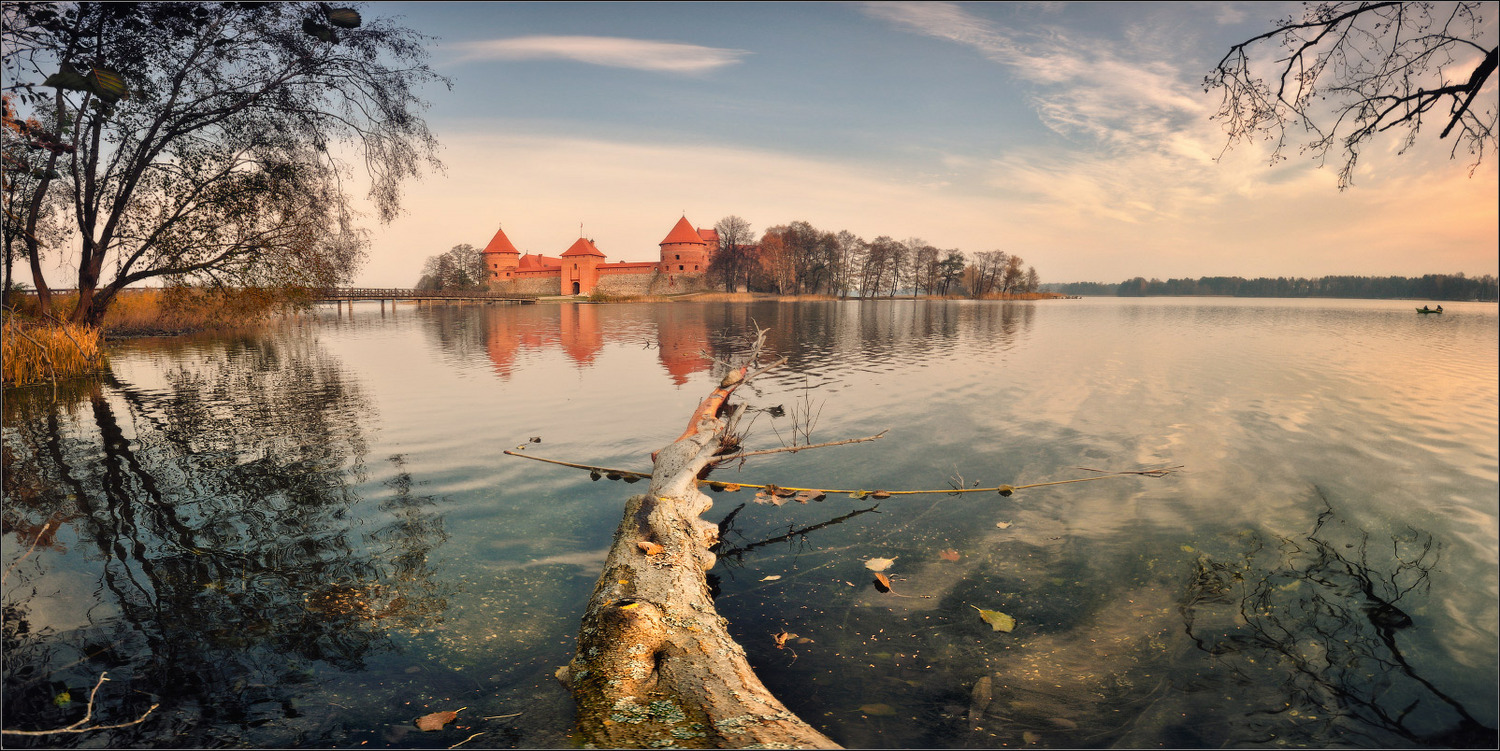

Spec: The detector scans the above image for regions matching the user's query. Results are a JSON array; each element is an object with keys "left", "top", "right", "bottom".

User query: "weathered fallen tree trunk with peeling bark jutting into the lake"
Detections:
[{"left": 558, "top": 348, "right": 839, "bottom": 748}]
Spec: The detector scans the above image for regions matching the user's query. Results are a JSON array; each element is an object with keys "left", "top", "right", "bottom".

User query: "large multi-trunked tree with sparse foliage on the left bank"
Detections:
[{"left": 0, "top": 1, "right": 443, "bottom": 322}]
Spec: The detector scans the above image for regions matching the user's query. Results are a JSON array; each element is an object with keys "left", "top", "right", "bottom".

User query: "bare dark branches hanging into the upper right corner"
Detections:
[{"left": 1205, "top": 1, "right": 1497, "bottom": 190}]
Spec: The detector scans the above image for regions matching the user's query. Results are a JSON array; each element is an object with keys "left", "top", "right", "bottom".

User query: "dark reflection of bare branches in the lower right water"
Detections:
[{"left": 1182, "top": 490, "right": 1496, "bottom": 748}]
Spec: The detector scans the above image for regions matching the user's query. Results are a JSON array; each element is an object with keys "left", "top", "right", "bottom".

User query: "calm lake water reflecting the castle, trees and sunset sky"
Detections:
[{"left": 3, "top": 298, "right": 1500, "bottom": 748}]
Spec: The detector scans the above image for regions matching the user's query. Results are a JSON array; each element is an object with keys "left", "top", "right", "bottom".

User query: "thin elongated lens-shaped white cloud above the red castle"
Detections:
[{"left": 452, "top": 36, "right": 750, "bottom": 73}]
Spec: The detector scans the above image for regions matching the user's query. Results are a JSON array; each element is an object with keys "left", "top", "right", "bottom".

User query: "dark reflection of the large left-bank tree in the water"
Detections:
[{"left": 3, "top": 337, "right": 446, "bottom": 745}]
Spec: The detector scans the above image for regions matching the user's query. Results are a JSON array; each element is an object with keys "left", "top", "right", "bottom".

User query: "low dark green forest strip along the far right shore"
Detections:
[{"left": 1041, "top": 273, "right": 1500, "bottom": 303}]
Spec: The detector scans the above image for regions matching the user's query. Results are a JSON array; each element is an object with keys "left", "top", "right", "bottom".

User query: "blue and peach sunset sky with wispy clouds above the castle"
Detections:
[{"left": 23, "top": 1, "right": 1500, "bottom": 286}]
